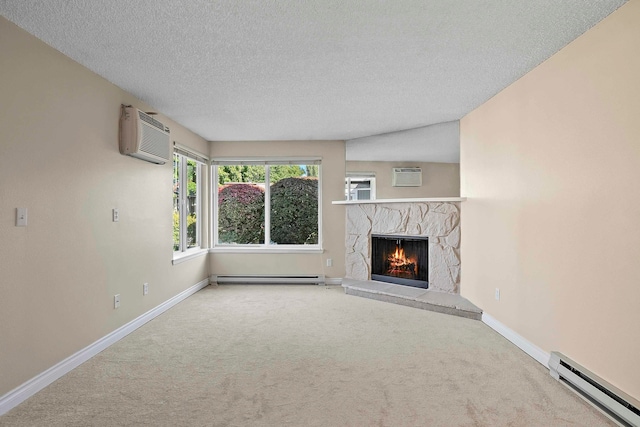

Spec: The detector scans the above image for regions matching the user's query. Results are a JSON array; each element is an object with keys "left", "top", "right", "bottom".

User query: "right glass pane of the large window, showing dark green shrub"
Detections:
[{"left": 270, "top": 165, "right": 319, "bottom": 245}]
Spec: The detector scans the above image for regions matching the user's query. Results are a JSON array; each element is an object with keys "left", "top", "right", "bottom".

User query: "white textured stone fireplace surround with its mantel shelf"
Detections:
[{"left": 333, "top": 197, "right": 465, "bottom": 294}]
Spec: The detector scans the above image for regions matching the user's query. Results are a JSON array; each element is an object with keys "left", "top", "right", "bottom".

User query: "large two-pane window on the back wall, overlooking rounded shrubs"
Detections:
[{"left": 213, "top": 159, "right": 321, "bottom": 249}]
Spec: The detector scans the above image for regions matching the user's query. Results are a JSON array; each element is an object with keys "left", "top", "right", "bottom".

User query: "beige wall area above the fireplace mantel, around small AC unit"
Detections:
[{"left": 347, "top": 162, "right": 460, "bottom": 199}]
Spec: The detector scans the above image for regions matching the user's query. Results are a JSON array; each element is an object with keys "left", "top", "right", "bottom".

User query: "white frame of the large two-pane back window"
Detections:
[{"left": 209, "top": 157, "right": 323, "bottom": 253}]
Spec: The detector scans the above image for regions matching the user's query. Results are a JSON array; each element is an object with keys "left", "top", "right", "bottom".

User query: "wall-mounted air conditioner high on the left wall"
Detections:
[{"left": 120, "top": 105, "right": 171, "bottom": 165}]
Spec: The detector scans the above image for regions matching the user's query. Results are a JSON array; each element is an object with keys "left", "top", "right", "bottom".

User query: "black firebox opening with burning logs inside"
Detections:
[{"left": 371, "top": 234, "right": 429, "bottom": 289}]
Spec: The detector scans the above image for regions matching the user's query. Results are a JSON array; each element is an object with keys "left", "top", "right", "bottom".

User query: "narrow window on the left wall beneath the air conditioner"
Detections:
[{"left": 173, "top": 150, "right": 204, "bottom": 252}]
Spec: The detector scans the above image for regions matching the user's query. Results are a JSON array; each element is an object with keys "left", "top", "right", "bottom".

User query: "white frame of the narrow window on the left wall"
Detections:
[{"left": 172, "top": 146, "right": 209, "bottom": 264}]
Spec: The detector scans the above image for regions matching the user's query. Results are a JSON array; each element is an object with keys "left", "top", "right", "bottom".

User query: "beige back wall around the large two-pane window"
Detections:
[{"left": 210, "top": 141, "right": 345, "bottom": 278}]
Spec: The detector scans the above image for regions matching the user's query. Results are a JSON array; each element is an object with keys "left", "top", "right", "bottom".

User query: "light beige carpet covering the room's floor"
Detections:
[{"left": 0, "top": 285, "right": 614, "bottom": 426}]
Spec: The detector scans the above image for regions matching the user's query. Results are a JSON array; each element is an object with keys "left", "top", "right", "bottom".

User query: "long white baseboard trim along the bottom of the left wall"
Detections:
[{"left": 0, "top": 278, "right": 209, "bottom": 415}]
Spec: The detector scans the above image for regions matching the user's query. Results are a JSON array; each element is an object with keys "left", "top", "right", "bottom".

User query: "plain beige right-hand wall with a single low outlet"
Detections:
[{"left": 460, "top": 0, "right": 640, "bottom": 399}]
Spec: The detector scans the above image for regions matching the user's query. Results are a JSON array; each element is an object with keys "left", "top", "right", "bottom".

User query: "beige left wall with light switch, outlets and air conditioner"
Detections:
[{"left": 0, "top": 17, "right": 208, "bottom": 396}]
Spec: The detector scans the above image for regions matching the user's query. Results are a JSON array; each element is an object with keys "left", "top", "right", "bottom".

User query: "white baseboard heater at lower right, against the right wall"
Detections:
[{"left": 549, "top": 351, "right": 640, "bottom": 427}]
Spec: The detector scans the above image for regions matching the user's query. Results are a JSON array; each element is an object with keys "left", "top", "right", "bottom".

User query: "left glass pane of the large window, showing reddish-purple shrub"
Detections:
[{"left": 217, "top": 165, "right": 265, "bottom": 245}]
